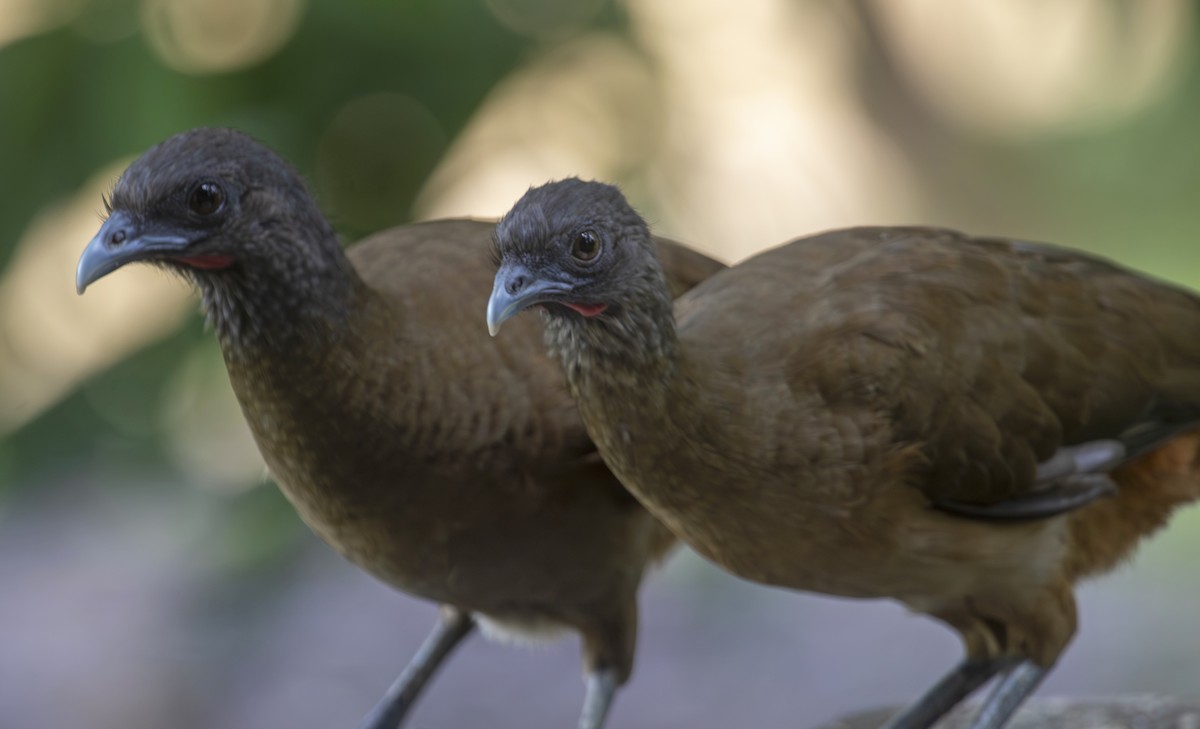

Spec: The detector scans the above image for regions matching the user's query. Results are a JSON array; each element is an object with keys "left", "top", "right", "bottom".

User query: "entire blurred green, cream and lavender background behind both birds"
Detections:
[{"left": 0, "top": 0, "right": 1200, "bottom": 729}]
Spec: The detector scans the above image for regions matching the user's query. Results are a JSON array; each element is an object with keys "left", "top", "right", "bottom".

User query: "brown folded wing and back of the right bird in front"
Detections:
[{"left": 677, "top": 228, "right": 1200, "bottom": 505}]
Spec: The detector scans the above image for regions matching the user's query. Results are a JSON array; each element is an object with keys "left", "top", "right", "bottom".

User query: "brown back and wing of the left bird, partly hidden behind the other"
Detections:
[{"left": 348, "top": 219, "right": 725, "bottom": 484}]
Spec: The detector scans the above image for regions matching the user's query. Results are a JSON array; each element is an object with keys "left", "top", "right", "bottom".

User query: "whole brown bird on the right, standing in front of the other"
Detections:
[{"left": 487, "top": 180, "right": 1200, "bottom": 728}]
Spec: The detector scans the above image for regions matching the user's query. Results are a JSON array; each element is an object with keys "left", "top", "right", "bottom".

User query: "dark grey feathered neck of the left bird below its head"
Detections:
[{"left": 193, "top": 230, "right": 366, "bottom": 356}]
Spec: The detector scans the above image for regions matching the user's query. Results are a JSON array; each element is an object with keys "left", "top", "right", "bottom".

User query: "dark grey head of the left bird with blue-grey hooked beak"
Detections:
[{"left": 76, "top": 128, "right": 334, "bottom": 294}]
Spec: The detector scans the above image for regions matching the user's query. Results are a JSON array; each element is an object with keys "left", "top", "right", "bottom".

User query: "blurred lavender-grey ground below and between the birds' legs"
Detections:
[{"left": 0, "top": 477, "right": 1200, "bottom": 729}]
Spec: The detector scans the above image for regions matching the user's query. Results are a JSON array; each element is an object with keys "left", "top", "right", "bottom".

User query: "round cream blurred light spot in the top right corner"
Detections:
[{"left": 874, "top": 0, "right": 1194, "bottom": 137}]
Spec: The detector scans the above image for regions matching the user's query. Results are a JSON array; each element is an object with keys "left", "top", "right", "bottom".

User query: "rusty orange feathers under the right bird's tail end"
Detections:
[{"left": 1067, "top": 429, "right": 1200, "bottom": 582}]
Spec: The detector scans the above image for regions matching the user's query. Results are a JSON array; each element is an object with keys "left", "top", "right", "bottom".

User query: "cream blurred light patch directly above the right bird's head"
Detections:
[{"left": 418, "top": 34, "right": 662, "bottom": 217}]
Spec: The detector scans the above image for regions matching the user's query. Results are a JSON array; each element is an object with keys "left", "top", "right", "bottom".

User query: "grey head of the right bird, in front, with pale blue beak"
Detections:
[{"left": 487, "top": 177, "right": 665, "bottom": 336}]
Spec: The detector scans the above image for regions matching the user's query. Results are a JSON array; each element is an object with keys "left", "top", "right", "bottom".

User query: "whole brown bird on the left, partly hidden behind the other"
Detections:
[{"left": 77, "top": 128, "right": 722, "bottom": 729}]
